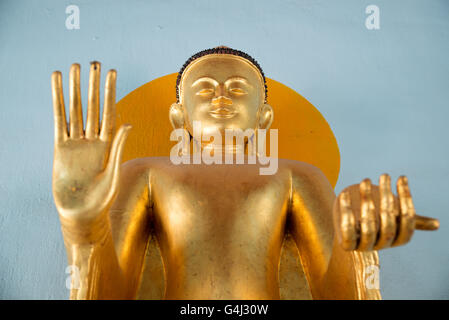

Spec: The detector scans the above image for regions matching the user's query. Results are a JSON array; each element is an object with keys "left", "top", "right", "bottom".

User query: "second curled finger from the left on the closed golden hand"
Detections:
[{"left": 357, "top": 179, "right": 378, "bottom": 251}]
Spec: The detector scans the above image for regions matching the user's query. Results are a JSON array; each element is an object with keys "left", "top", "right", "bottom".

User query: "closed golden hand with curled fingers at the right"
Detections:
[{"left": 334, "top": 174, "right": 439, "bottom": 251}]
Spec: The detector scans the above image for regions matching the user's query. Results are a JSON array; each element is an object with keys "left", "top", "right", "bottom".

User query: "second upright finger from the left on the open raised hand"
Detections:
[{"left": 69, "top": 63, "right": 83, "bottom": 139}]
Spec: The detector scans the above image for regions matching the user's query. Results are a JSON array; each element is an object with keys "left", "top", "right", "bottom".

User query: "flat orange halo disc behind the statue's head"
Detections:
[{"left": 117, "top": 73, "right": 340, "bottom": 187}]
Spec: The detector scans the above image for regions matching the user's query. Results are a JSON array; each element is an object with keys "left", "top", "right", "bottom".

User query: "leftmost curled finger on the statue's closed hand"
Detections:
[{"left": 337, "top": 191, "right": 358, "bottom": 250}]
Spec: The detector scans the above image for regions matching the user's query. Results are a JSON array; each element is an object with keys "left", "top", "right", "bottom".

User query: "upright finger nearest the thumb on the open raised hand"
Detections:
[{"left": 100, "top": 70, "right": 117, "bottom": 141}]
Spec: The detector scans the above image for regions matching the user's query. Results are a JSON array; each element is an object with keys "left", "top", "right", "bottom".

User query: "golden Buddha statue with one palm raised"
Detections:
[{"left": 52, "top": 47, "right": 438, "bottom": 299}]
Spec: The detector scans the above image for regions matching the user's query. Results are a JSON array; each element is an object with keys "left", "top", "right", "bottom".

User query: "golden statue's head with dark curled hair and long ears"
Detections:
[{"left": 170, "top": 47, "right": 273, "bottom": 140}]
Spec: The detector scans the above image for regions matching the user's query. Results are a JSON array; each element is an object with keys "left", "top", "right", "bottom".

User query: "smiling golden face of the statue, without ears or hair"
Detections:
[{"left": 180, "top": 54, "right": 265, "bottom": 134}]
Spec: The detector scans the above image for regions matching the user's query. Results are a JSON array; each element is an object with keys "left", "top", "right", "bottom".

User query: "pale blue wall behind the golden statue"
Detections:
[{"left": 0, "top": 0, "right": 449, "bottom": 299}]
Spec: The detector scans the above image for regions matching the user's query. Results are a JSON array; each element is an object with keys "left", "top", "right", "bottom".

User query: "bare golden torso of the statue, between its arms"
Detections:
[{"left": 112, "top": 158, "right": 314, "bottom": 299}]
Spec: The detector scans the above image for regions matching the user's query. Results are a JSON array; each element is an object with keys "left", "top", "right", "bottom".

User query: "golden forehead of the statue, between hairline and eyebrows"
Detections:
[{"left": 181, "top": 54, "right": 263, "bottom": 86}]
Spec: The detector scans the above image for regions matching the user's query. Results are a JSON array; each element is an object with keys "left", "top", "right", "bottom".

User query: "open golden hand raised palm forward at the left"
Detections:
[{"left": 52, "top": 62, "right": 131, "bottom": 222}]
